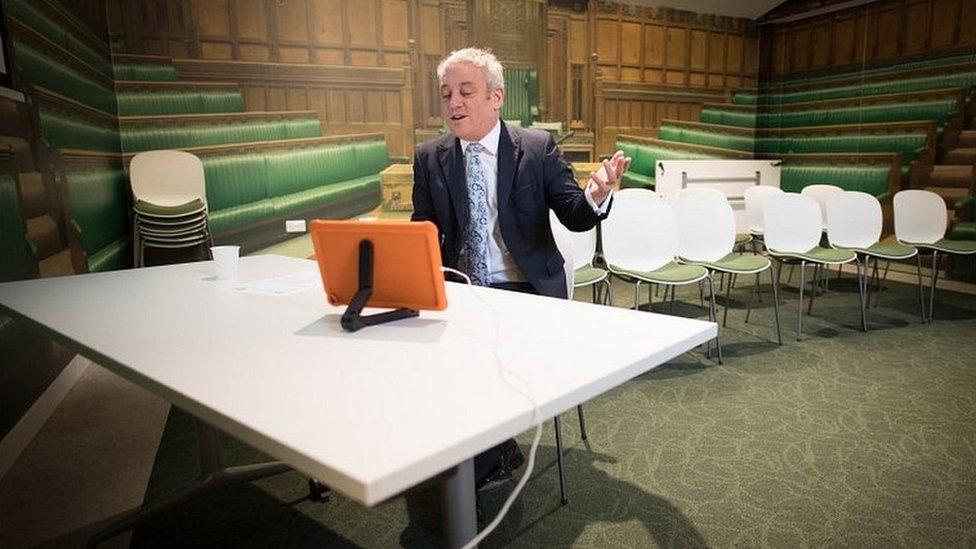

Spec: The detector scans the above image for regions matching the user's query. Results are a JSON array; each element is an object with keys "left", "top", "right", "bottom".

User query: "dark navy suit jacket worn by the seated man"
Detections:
[{"left": 411, "top": 122, "right": 609, "bottom": 297}]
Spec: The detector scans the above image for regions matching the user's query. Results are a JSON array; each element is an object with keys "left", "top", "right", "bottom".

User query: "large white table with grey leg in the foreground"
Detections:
[{"left": 0, "top": 256, "right": 716, "bottom": 545}]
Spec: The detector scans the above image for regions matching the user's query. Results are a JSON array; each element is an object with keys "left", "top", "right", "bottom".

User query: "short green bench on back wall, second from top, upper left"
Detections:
[{"left": 117, "top": 89, "right": 244, "bottom": 116}]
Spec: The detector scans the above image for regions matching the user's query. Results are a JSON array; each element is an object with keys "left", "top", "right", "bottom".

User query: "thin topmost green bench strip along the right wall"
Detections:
[{"left": 732, "top": 71, "right": 976, "bottom": 105}]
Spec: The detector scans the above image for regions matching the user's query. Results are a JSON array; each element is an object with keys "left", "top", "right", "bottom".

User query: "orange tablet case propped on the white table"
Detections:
[{"left": 309, "top": 219, "right": 447, "bottom": 311}]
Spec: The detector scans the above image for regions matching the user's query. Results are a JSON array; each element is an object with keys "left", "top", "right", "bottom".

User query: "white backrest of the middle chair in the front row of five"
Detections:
[{"left": 763, "top": 193, "right": 823, "bottom": 253}]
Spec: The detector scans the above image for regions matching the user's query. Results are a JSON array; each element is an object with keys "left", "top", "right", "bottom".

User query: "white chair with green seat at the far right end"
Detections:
[{"left": 894, "top": 190, "right": 976, "bottom": 322}]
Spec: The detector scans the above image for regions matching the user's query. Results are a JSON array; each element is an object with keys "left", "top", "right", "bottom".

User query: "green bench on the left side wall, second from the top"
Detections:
[{"left": 14, "top": 40, "right": 116, "bottom": 115}]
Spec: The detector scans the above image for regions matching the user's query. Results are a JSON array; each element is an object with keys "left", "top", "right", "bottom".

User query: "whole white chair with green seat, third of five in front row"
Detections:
[{"left": 763, "top": 193, "right": 867, "bottom": 341}]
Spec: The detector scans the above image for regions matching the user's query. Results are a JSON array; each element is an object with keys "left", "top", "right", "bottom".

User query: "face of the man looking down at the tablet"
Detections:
[{"left": 440, "top": 63, "right": 505, "bottom": 141}]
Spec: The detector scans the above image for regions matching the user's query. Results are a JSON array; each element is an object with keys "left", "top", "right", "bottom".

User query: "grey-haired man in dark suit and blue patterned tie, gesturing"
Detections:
[{"left": 411, "top": 48, "right": 630, "bottom": 486}]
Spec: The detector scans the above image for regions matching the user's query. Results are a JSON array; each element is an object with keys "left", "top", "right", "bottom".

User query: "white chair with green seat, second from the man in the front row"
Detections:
[{"left": 672, "top": 189, "right": 782, "bottom": 344}]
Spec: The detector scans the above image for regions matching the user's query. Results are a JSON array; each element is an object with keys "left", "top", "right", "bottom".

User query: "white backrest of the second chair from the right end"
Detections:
[{"left": 827, "top": 191, "right": 882, "bottom": 248}]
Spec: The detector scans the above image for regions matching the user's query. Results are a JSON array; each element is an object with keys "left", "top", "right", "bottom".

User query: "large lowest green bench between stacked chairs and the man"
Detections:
[{"left": 199, "top": 135, "right": 390, "bottom": 249}]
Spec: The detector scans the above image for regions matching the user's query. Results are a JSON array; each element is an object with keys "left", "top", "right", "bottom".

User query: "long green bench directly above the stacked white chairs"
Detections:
[{"left": 122, "top": 117, "right": 322, "bottom": 151}]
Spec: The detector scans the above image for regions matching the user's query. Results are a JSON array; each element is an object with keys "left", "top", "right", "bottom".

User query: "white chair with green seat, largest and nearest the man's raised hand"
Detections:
[{"left": 602, "top": 189, "right": 722, "bottom": 361}]
